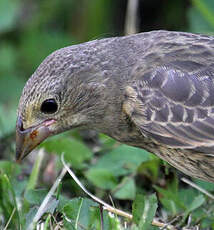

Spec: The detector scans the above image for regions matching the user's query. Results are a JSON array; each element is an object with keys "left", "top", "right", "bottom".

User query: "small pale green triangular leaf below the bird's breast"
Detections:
[{"left": 113, "top": 177, "right": 136, "bottom": 200}]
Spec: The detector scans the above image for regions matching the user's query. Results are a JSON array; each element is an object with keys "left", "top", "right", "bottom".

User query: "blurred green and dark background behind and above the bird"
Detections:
[{"left": 0, "top": 0, "right": 214, "bottom": 158}]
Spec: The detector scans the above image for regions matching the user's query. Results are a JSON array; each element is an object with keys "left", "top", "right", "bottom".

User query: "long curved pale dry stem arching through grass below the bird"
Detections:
[{"left": 61, "top": 154, "right": 176, "bottom": 230}]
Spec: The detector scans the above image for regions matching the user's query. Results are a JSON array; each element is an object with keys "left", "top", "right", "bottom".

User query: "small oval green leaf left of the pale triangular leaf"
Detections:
[{"left": 86, "top": 168, "right": 117, "bottom": 189}]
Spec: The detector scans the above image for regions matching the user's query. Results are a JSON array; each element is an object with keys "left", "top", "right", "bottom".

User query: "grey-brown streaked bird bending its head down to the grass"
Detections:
[{"left": 16, "top": 30, "right": 214, "bottom": 182}]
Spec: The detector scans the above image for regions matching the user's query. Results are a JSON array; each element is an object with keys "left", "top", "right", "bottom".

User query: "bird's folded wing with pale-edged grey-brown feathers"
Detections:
[{"left": 124, "top": 67, "right": 214, "bottom": 152}]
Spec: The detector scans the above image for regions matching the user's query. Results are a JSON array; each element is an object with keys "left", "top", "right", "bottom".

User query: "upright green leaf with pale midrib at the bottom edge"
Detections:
[{"left": 132, "top": 194, "right": 158, "bottom": 229}]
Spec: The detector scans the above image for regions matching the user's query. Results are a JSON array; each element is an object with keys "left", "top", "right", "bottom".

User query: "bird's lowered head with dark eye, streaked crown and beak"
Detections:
[{"left": 16, "top": 46, "right": 108, "bottom": 161}]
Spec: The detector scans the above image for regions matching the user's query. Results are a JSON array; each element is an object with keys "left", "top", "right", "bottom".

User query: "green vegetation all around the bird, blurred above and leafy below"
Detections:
[{"left": 0, "top": 0, "right": 214, "bottom": 230}]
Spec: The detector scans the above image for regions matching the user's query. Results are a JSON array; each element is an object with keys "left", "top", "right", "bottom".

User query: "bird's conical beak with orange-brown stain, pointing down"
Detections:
[{"left": 16, "top": 117, "right": 56, "bottom": 162}]
